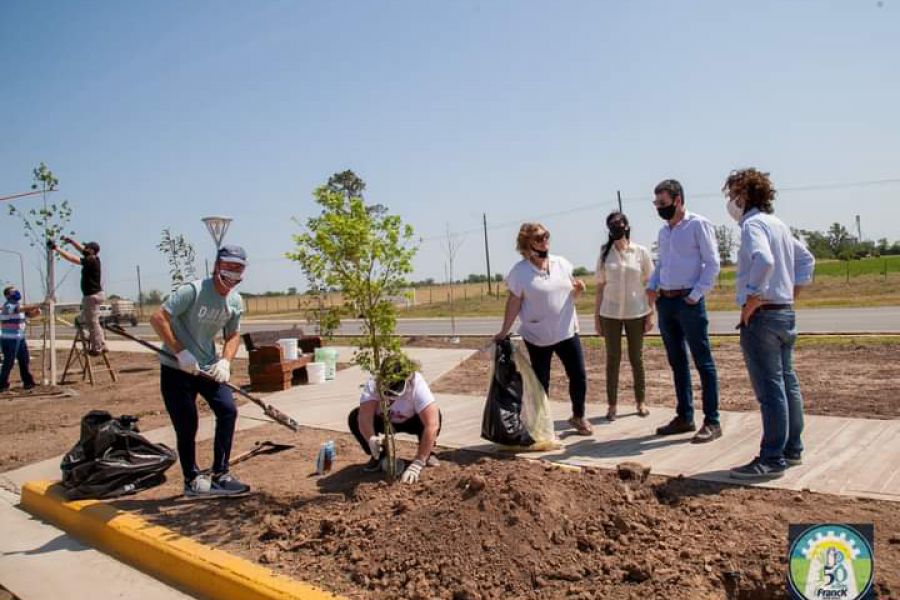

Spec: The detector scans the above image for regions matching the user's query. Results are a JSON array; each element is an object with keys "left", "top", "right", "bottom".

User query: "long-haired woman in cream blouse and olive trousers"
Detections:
[{"left": 594, "top": 211, "right": 653, "bottom": 421}]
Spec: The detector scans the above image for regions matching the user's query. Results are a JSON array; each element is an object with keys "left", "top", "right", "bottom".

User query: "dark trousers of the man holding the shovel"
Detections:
[{"left": 160, "top": 365, "right": 237, "bottom": 482}]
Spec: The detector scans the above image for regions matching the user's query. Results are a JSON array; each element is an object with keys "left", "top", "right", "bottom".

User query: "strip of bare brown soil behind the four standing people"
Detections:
[{"left": 432, "top": 340, "right": 900, "bottom": 419}]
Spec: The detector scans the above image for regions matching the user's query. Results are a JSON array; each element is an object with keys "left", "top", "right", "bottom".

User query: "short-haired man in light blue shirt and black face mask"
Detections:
[{"left": 647, "top": 179, "right": 722, "bottom": 443}]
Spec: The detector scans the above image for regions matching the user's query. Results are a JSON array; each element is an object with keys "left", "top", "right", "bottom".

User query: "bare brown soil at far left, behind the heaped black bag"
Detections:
[{"left": 0, "top": 351, "right": 249, "bottom": 471}]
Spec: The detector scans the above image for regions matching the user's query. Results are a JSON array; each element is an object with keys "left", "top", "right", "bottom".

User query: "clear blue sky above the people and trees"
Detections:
[{"left": 0, "top": 0, "right": 900, "bottom": 299}]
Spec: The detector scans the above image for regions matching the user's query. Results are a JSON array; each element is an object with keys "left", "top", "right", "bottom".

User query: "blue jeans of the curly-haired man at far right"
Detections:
[{"left": 741, "top": 310, "right": 803, "bottom": 465}]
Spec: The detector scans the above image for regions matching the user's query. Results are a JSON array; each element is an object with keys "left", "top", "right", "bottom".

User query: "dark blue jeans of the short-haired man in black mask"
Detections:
[{"left": 656, "top": 296, "right": 719, "bottom": 425}]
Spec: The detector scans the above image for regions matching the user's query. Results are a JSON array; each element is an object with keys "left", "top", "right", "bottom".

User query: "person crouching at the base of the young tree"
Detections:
[{"left": 348, "top": 354, "right": 441, "bottom": 483}]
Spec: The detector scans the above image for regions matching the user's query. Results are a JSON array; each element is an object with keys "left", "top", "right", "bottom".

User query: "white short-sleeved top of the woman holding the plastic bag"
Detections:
[{"left": 506, "top": 254, "right": 578, "bottom": 346}]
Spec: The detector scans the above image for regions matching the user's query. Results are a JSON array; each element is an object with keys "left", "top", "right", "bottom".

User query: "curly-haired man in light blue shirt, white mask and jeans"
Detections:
[{"left": 722, "top": 168, "right": 816, "bottom": 480}]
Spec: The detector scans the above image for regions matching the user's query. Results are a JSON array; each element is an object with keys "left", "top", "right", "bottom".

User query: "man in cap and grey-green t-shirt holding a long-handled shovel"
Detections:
[{"left": 150, "top": 245, "right": 250, "bottom": 496}]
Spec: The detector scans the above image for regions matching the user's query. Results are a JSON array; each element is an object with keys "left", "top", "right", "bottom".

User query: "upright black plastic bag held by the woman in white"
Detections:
[{"left": 481, "top": 338, "right": 534, "bottom": 447}]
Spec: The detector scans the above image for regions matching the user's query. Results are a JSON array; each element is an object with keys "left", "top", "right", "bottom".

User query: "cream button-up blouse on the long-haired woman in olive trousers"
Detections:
[{"left": 594, "top": 243, "right": 653, "bottom": 320}]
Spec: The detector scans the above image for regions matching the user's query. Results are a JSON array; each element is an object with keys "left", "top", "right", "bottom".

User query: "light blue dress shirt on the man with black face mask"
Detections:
[{"left": 647, "top": 211, "right": 719, "bottom": 302}]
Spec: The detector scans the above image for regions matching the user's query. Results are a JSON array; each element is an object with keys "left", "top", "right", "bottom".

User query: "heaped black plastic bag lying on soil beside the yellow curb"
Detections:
[{"left": 60, "top": 410, "right": 176, "bottom": 500}]
